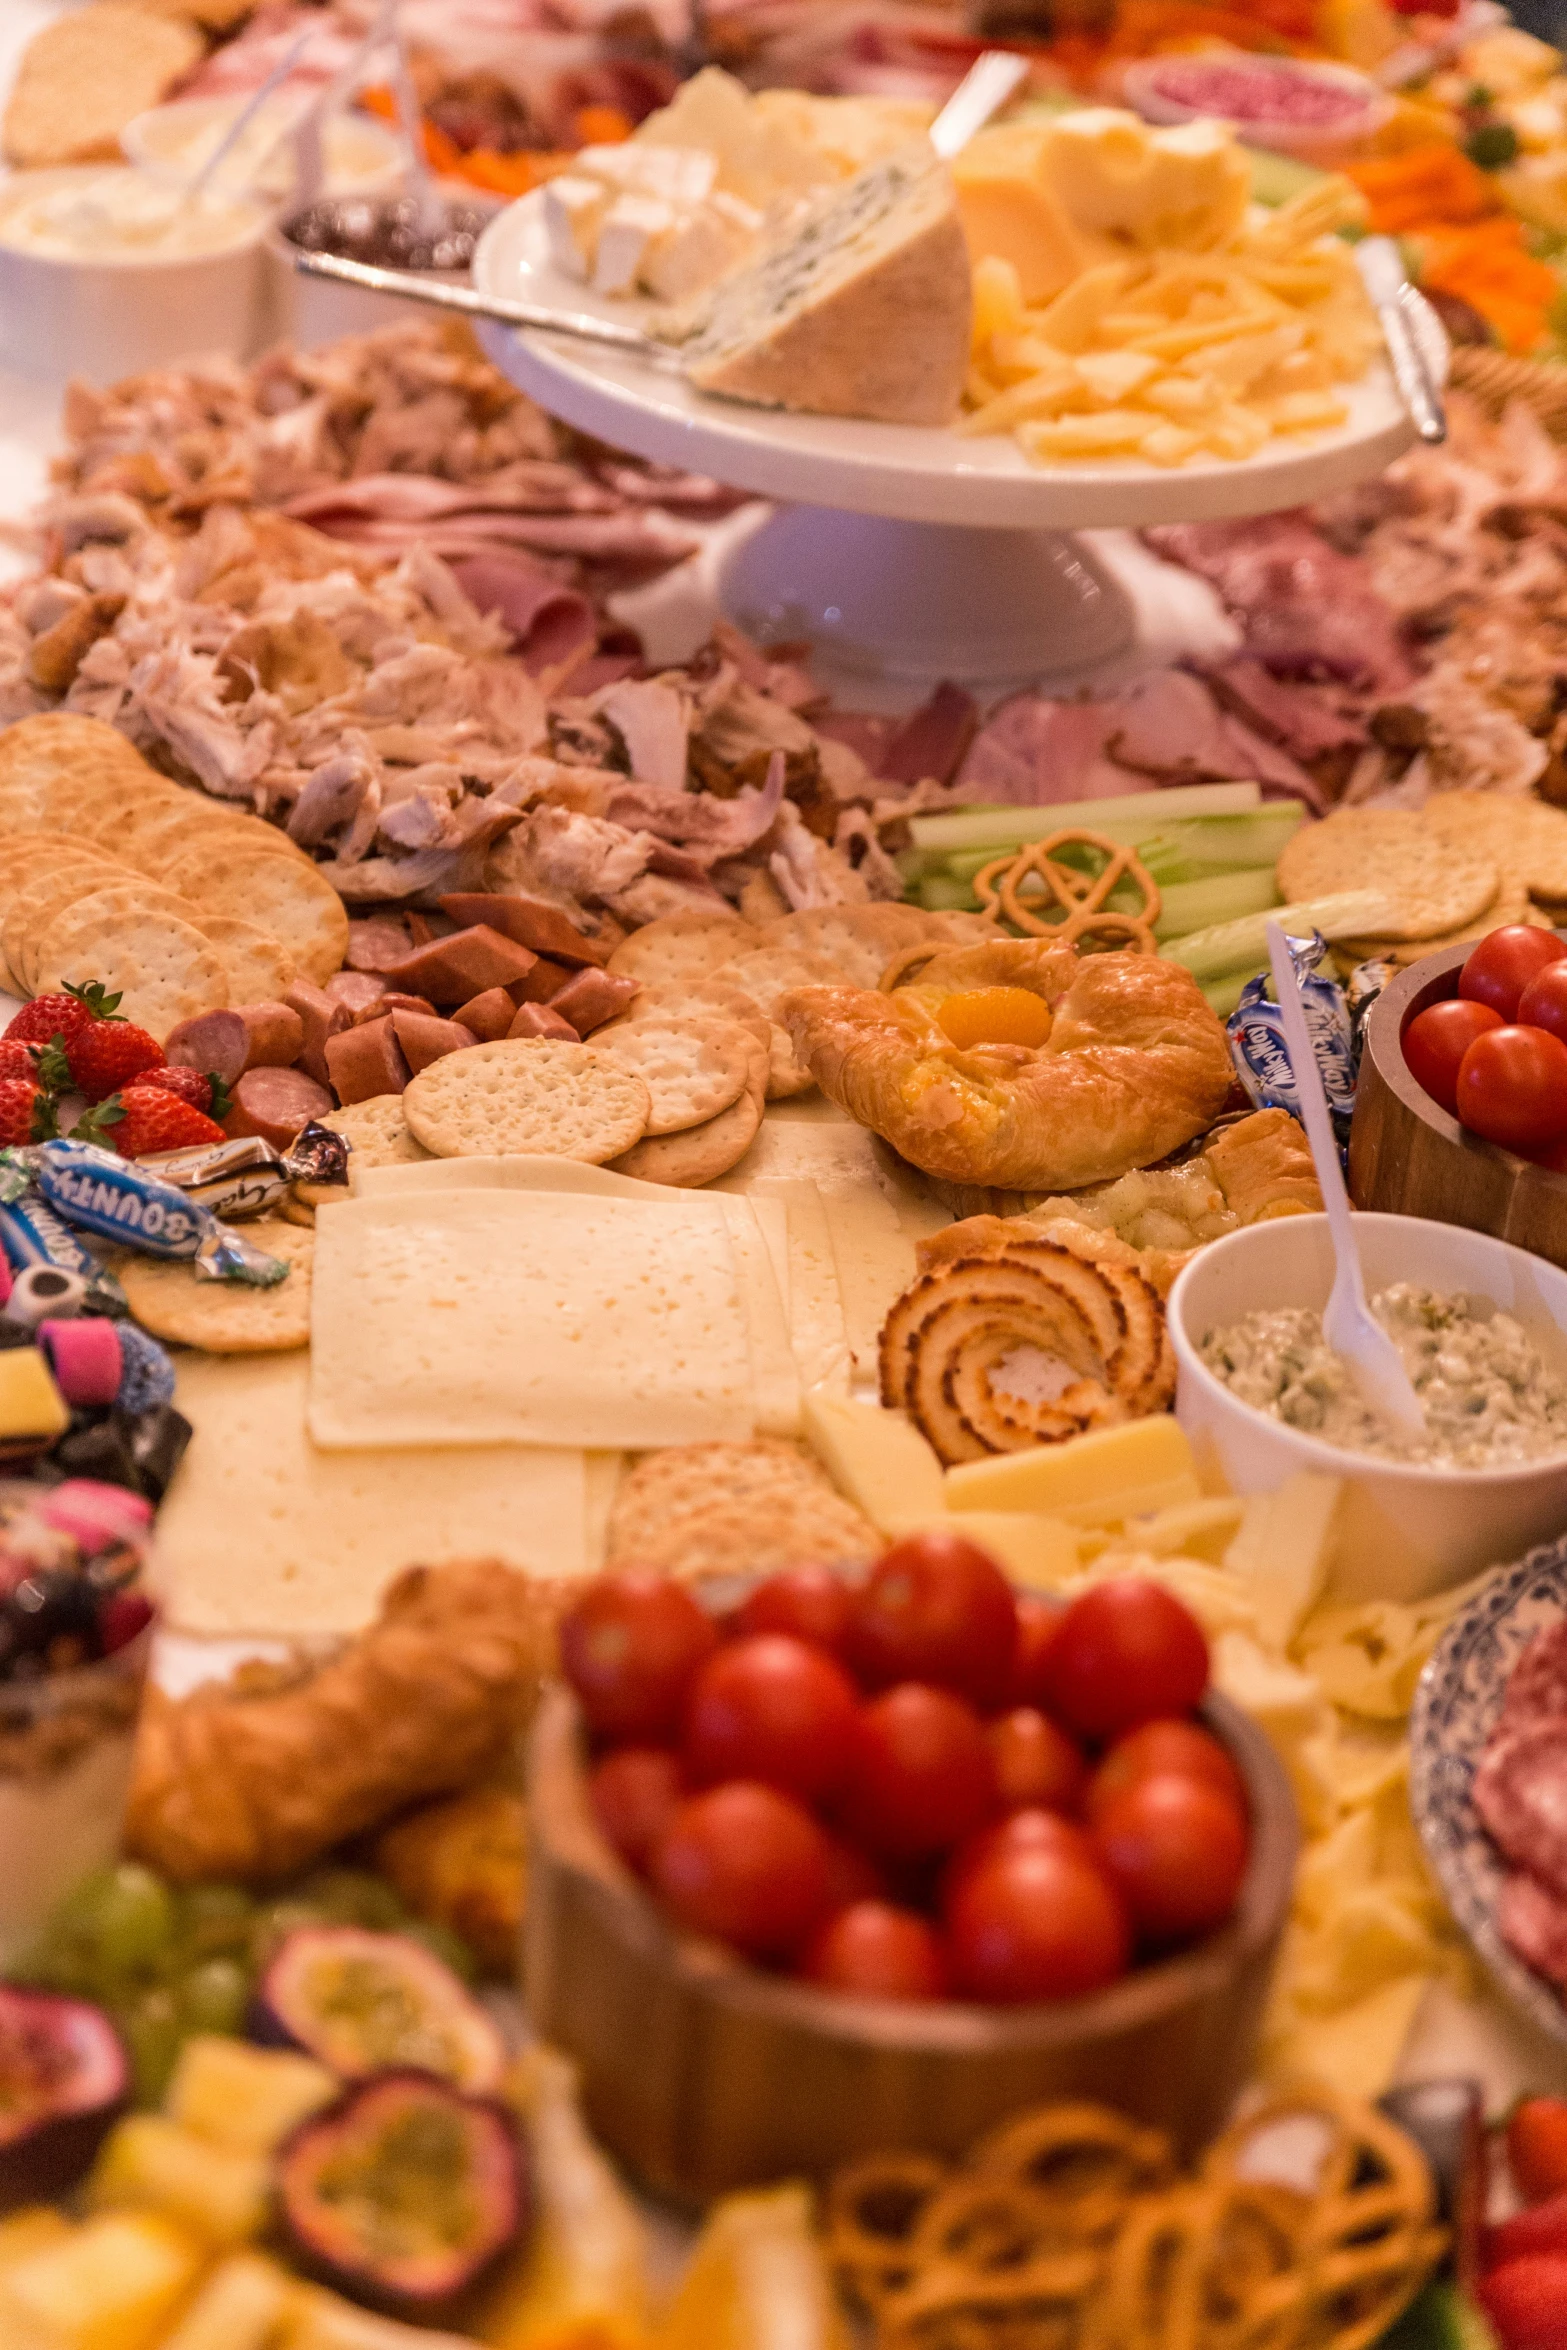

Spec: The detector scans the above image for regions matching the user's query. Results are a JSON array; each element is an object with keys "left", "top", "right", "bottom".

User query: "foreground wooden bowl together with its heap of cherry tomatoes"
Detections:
[{"left": 524, "top": 1532, "right": 1297, "bottom": 2204}]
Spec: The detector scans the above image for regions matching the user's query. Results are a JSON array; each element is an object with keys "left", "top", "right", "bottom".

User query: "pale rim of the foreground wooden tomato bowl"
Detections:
[{"left": 529, "top": 1683, "right": 1299, "bottom": 2054}]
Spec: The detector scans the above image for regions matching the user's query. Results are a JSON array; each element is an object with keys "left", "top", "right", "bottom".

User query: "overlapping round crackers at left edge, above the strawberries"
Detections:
[{"left": 0, "top": 714, "right": 348, "bottom": 1041}]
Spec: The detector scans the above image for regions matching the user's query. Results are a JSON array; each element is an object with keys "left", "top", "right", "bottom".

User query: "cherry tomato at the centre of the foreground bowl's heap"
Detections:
[{"left": 841, "top": 1680, "right": 996, "bottom": 1861}]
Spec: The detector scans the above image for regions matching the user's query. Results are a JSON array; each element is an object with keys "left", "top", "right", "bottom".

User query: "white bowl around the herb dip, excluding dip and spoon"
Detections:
[{"left": 1170, "top": 1215, "right": 1567, "bottom": 1600}]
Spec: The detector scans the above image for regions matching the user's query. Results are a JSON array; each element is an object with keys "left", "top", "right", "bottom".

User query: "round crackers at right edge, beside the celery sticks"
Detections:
[{"left": 1278, "top": 792, "right": 1567, "bottom": 971}]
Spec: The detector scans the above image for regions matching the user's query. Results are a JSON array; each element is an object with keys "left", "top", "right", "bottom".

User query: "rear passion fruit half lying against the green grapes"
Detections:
[{"left": 251, "top": 1925, "right": 505, "bottom": 2096}]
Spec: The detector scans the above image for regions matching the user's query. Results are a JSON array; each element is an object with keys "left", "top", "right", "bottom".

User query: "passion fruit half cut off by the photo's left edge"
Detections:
[{"left": 0, "top": 1983, "right": 132, "bottom": 2211}]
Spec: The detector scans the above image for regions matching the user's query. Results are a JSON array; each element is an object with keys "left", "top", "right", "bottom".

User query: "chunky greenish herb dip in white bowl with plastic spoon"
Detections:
[{"left": 1201, "top": 1281, "right": 1567, "bottom": 1469}]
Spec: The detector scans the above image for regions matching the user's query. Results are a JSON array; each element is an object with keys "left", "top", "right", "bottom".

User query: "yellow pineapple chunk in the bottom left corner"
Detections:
[{"left": 5, "top": 2214, "right": 204, "bottom": 2350}]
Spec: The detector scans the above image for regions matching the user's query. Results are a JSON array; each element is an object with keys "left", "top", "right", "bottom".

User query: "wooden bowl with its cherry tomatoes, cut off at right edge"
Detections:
[{"left": 1349, "top": 924, "right": 1567, "bottom": 1267}]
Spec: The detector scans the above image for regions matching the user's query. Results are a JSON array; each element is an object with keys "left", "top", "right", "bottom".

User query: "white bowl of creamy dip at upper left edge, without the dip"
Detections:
[{"left": 0, "top": 165, "right": 268, "bottom": 383}]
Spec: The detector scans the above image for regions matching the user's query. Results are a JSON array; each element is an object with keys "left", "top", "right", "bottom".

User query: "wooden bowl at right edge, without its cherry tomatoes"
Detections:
[{"left": 1349, "top": 947, "right": 1567, "bottom": 1267}]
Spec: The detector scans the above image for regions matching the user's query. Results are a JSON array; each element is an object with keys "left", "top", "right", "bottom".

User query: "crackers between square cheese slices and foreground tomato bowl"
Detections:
[{"left": 604, "top": 1436, "right": 881, "bottom": 1582}]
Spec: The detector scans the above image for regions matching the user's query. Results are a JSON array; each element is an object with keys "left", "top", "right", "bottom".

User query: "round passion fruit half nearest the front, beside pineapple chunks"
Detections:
[{"left": 277, "top": 2073, "right": 531, "bottom": 2319}]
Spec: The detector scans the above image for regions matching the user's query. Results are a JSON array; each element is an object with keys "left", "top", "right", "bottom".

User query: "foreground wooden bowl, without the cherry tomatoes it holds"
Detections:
[{"left": 524, "top": 1687, "right": 1297, "bottom": 2204}]
